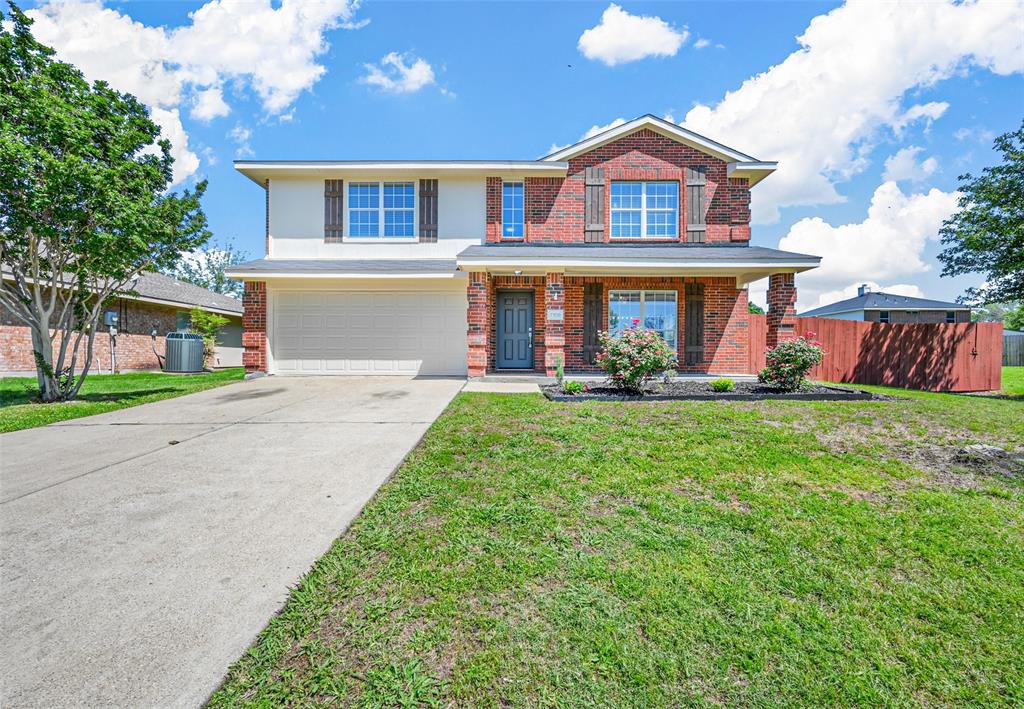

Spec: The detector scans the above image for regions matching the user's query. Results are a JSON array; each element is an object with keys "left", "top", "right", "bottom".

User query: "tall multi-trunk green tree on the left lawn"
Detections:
[{"left": 0, "top": 3, "right": 210, "bottom": 402}]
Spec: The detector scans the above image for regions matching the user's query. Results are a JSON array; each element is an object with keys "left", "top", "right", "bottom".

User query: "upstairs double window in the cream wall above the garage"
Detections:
[{"left": 347, "top": 181, "right": 416, "bottom": 239}]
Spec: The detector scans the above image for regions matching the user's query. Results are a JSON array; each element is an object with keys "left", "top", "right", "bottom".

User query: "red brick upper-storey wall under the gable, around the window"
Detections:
[{"left": 486, "top": 128, "right": 751, "bottom": 243}]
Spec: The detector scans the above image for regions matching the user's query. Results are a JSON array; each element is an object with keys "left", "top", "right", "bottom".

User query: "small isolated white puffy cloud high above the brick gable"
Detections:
[{"left": 578, "top": 3, "right": 690, "bottom": 67}]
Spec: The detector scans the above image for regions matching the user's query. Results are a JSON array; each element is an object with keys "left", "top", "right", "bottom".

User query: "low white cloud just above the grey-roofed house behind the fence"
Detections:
[{"left": 778, "top": 182, "right": 959, "bottom": 308}]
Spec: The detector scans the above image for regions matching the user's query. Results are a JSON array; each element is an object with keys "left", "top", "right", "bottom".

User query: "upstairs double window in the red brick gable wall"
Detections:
[{"left": 611, "top": 182, "right": 679, "bottom": 239}]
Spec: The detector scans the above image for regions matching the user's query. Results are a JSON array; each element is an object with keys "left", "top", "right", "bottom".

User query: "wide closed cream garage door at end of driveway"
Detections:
[{"left": 270, "top": 291, "right": 466, "bottom": 376}]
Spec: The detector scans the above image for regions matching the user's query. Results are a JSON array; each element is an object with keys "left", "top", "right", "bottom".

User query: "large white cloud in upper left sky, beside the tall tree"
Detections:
[{"left": 29, "top": 0, "right": 358, "bottom": 183}]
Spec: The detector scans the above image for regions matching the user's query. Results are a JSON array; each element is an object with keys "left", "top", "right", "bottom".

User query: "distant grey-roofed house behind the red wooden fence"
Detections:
[{"left": 800, "top": 285, "right": 971, "bottom": 324}]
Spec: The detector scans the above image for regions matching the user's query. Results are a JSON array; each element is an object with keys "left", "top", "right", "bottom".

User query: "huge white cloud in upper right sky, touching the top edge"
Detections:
[{"left": 683, "top": 0, "right": 1024, "bottom": 223}]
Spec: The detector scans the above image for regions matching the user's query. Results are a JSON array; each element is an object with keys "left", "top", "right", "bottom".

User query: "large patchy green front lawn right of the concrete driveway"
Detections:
[{"left": 211, "top": 373, "right": 1024, "bottom": 708}]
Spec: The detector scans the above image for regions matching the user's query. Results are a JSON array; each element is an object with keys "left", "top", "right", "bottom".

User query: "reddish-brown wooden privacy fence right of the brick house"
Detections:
[{"left": 750, "top": 315, "right": 1002, "bottom": 391}]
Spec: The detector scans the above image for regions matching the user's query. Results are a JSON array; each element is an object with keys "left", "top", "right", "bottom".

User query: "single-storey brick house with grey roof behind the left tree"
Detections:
[{"left": 0, "top": 273, "right": 242, "bottom": 374}]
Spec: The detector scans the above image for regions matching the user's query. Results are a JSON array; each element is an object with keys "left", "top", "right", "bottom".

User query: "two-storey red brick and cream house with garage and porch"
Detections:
[{"left": 228, "top": 116, "right": 820, "bottom": 376}]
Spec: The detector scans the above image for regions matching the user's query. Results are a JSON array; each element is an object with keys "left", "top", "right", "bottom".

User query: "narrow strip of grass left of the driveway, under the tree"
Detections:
[{"left": 0, "top": 368, "right": 245, "bottom": 433}]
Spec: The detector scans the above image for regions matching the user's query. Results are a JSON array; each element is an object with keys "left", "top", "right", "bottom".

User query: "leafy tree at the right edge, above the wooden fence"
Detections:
[{"left": 939, "top": 123, "right": 1024, "bottom": 303}]
